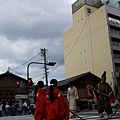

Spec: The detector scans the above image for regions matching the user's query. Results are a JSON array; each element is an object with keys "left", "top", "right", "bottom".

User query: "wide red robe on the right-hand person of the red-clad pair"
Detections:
[{"left": 46, "top": 88, "right": 69, "bottom": 120}]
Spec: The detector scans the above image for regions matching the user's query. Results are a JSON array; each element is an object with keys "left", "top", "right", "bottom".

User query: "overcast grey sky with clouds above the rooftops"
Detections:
[{"left": 0, "top": 0, "right": 76, "bottom": 83}]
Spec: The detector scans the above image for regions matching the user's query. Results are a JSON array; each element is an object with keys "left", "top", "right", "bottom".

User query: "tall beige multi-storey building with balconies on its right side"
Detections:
[{"left": 64, "top": 0, "right": 120, "bottom": 87}]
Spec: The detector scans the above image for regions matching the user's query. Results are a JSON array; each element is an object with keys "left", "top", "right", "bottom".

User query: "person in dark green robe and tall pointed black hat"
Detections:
[{"left": 98, "top": 71, "right": 113, "bottom": 117}]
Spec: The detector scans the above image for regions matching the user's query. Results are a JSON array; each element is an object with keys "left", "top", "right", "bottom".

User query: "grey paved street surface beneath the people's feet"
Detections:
[{"left": 0, "top": 109, "right": 120, "bottom": 120}]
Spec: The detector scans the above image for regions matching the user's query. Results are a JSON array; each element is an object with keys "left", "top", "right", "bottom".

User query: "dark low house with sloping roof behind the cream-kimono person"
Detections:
[{"left": 58, "top": 72, "right": 101, "bottom": 99}]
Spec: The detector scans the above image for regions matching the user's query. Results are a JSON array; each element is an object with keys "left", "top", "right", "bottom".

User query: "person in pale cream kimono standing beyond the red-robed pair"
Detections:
[{"left": 67, "top": 82, "right": 78, "bottom": 118}]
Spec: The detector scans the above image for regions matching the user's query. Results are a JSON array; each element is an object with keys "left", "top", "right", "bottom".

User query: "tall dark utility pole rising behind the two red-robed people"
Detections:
[{"left": 41, "top": 48, "right": 48, "bottom": 91}]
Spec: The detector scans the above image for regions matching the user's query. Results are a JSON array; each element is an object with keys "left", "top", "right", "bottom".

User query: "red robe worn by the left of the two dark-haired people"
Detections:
[{"left": 34, "top": 88, "right": 46, "bottom": 120}]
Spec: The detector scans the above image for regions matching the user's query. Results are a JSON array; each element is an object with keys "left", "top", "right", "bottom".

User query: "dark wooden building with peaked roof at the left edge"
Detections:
[{"left": 0, "top": 71, "right": 28, "bottom": 105}]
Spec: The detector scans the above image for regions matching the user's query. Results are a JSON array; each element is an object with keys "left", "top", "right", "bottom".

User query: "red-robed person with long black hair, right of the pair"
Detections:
[{"left": 46, "top": 79, "right": 69, "bottom": 120}]
